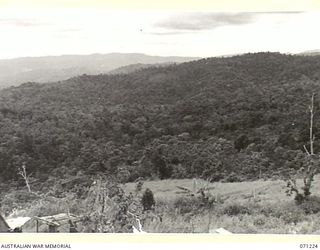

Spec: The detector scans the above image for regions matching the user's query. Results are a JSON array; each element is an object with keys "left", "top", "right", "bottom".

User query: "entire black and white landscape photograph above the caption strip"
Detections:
[{"left": 0, "top": 1, "right": 320, "bottom": 235}]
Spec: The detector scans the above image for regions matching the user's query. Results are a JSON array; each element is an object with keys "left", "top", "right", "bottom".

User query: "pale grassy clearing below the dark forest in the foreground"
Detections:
[{"left": 124, "top": 176, "right": 320, "bottom": 234}]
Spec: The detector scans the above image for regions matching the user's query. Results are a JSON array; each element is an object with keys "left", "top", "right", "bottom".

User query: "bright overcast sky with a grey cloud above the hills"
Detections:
[{"left": 0, "top": 9, "right": 320, "bottom": 58}]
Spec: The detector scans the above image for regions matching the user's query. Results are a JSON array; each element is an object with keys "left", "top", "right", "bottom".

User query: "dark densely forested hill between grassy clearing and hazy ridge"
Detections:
[{"left": 0, "top": 53, "right": 320, "bottom": 188}]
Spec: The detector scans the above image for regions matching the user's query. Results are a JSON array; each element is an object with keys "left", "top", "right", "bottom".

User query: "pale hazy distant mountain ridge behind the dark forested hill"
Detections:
[{"left": 0, "top": 53, "right": 198, "bottom": 87}]
